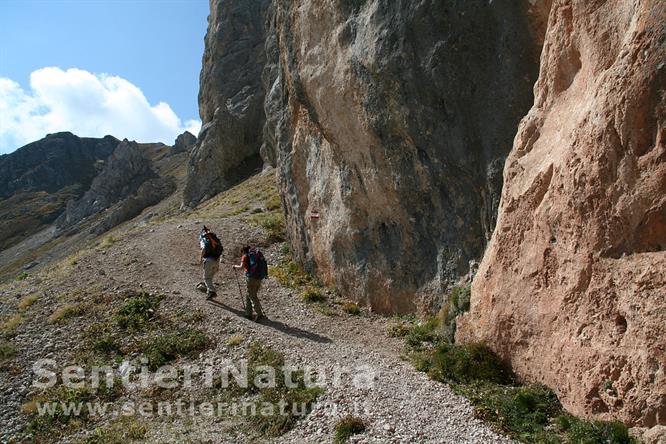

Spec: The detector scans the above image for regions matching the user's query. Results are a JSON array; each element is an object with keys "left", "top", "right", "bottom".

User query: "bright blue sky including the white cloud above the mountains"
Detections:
[{"left": 0, "top": 0, "right": 208, "bottom": 153}]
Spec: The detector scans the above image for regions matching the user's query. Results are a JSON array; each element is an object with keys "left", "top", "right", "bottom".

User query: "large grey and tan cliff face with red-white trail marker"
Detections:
[{"left": 263, "top": 0, "right": 542, "bottom": 312}]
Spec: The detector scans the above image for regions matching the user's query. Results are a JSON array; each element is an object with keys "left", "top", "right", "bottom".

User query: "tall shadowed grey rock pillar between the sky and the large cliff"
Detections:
[{"left": 184, "top": 0, "right": 269, "bottom": 205}]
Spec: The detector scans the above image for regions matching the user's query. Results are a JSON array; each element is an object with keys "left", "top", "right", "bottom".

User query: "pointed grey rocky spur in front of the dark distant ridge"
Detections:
[{"left": 56, "top": 139, "right": 176, "bottom": 233}]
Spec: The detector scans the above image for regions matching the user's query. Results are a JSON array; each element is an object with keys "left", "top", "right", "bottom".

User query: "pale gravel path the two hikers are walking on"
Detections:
[{"left": 0, "top": 197, "right": 511, "bottom": 443}]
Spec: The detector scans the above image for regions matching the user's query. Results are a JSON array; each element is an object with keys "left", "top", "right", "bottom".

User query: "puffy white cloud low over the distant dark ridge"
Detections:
[{"left": 0, "top": 68, "right": 201, "bottom": 153}]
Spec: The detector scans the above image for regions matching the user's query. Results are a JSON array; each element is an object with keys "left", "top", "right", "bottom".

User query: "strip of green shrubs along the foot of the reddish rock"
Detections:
[{"left": 396, "top": 314, "right": 634, "bottom": 444}]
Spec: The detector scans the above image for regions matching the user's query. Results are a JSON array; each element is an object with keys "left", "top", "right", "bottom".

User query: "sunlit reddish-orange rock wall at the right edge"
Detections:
[{"left": 457, "top": 0, "right": 666, "bottom": 427}]
